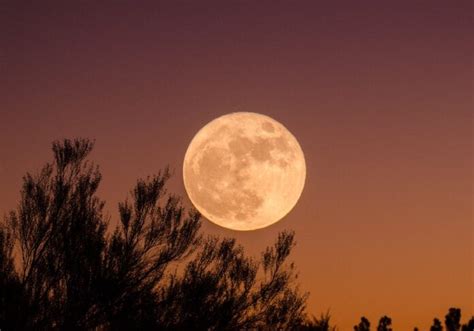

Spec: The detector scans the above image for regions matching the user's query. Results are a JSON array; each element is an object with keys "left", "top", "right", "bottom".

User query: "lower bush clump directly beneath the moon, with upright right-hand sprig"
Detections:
[{"left": 154, "top": 232, "right": 306, "bottom": 330}]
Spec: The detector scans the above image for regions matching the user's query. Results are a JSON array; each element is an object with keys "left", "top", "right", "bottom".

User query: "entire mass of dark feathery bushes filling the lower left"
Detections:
[{"left": 0, "top": 139, "right": 307, "bottom": 330}]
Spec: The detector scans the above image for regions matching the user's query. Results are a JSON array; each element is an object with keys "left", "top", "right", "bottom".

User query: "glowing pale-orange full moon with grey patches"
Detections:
[{"left": 183, "top": 112, "right": 306, "bottom": 231}]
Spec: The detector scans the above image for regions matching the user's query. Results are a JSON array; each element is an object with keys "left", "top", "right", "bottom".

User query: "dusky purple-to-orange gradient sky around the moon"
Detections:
[{"left": 0, "top": 0, "right": 474, "bottom": 330}]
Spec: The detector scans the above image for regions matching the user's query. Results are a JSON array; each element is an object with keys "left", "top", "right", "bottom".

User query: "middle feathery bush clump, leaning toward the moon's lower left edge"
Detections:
[{"left": 99, "top": 170, "right": 201, "bottom": 329}]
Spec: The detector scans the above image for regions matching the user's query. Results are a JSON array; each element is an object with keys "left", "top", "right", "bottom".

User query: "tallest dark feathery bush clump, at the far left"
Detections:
[{"left": 7, "top": 140, "right": 106, "bottom": 330}]
